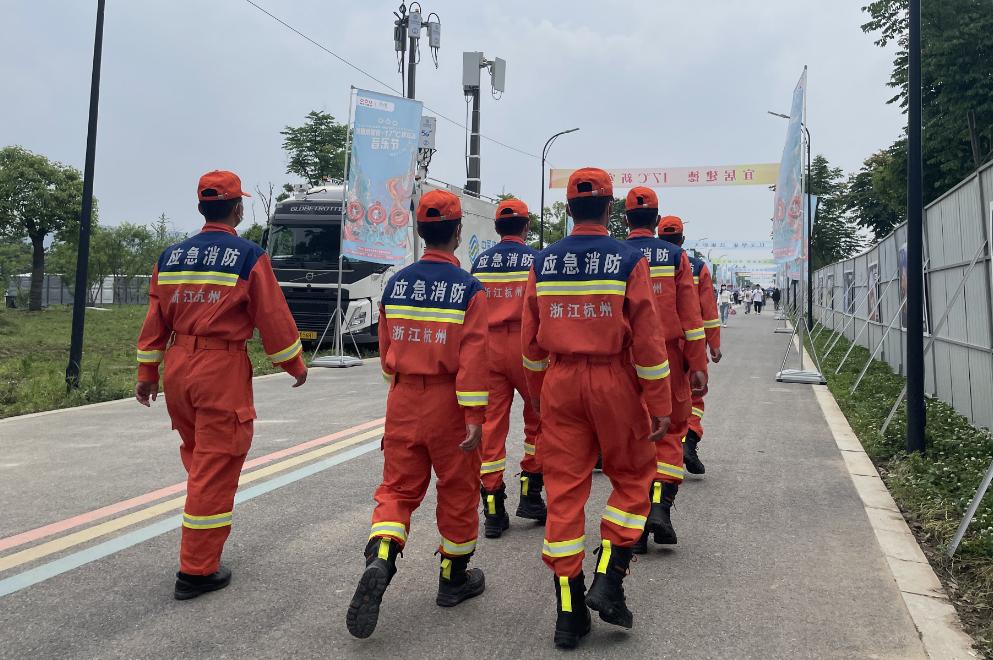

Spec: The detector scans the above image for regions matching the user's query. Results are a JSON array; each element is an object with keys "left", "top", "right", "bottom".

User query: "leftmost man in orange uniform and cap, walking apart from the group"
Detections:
[{"left": 135, "top": 170, "right": 307, "bottom": 600}]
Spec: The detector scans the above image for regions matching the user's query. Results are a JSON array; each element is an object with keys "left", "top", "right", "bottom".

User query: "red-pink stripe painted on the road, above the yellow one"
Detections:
[{"left": 0, "top": 418, "right": 386, "bottom": 552}]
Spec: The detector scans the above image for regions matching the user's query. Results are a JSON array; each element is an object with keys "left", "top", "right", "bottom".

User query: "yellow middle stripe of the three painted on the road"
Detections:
[{"left": 0, "top": 427, "right": 383, "bottom": 571}]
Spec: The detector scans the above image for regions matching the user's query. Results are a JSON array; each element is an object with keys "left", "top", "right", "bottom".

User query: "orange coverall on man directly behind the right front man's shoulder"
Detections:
[{"left": 628, "top": 229, "right": 707, "bottom": 484}]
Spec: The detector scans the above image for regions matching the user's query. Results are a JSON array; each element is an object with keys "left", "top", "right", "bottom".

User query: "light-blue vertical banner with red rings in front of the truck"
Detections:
[{"left": 341, "top": 89, "right": 422, "bottom": 265}]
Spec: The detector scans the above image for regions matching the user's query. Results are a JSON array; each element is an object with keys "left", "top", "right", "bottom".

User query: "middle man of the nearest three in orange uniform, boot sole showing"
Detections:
[{"left": 346, "top": 190, "right": 489, "bottom": 638}]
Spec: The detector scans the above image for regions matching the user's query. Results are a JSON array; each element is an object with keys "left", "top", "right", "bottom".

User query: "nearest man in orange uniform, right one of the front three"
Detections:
[{"left": 521, "top": 168, "right": 672, "bottom": 648}]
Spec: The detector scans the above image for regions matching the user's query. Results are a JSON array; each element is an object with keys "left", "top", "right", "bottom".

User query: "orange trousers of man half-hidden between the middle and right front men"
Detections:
[{"left": 480, "top": 326, "right": 541, "bottom": 491}]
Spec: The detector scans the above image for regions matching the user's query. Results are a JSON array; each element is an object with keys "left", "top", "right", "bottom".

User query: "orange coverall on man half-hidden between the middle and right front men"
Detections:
[{"left": 472, "top": 236, "right": 541, "bottom": 491}]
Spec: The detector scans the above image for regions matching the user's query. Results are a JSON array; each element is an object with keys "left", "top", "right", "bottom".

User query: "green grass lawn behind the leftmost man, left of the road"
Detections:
[{"left": 0, "top": 305, "right": 277, "bottom": 417}]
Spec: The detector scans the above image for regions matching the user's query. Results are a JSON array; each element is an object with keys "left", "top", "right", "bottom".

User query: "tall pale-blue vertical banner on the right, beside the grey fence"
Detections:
[{"left": 772, "top": 67, "right": 807, "bottom": 264}]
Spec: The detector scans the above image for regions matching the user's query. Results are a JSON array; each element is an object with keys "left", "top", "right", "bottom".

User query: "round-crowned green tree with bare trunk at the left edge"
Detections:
[{"left": 0, "top": 146, "right": 88, "bottom": 311}]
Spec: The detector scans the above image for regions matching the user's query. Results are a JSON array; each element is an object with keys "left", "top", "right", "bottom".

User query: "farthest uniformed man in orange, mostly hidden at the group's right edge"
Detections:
[{"left": 659, "top": 216, "right": 721, "bottom": 474}]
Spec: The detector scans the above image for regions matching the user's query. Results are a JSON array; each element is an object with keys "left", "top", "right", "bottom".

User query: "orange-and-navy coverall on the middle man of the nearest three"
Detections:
[{"left": 369, "top": 249, "right": 489, "bottom": 558}]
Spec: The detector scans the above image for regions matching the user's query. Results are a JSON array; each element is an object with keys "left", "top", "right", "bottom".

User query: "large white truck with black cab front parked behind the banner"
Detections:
[{"left": 263, "top": 180, "right": 499, "bottom": 346}]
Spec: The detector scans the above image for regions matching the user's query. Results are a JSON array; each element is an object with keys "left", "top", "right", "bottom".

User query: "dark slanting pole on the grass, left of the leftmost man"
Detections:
[{"left": 66, "top": 0, "right": 105, "bottom": 389}]
